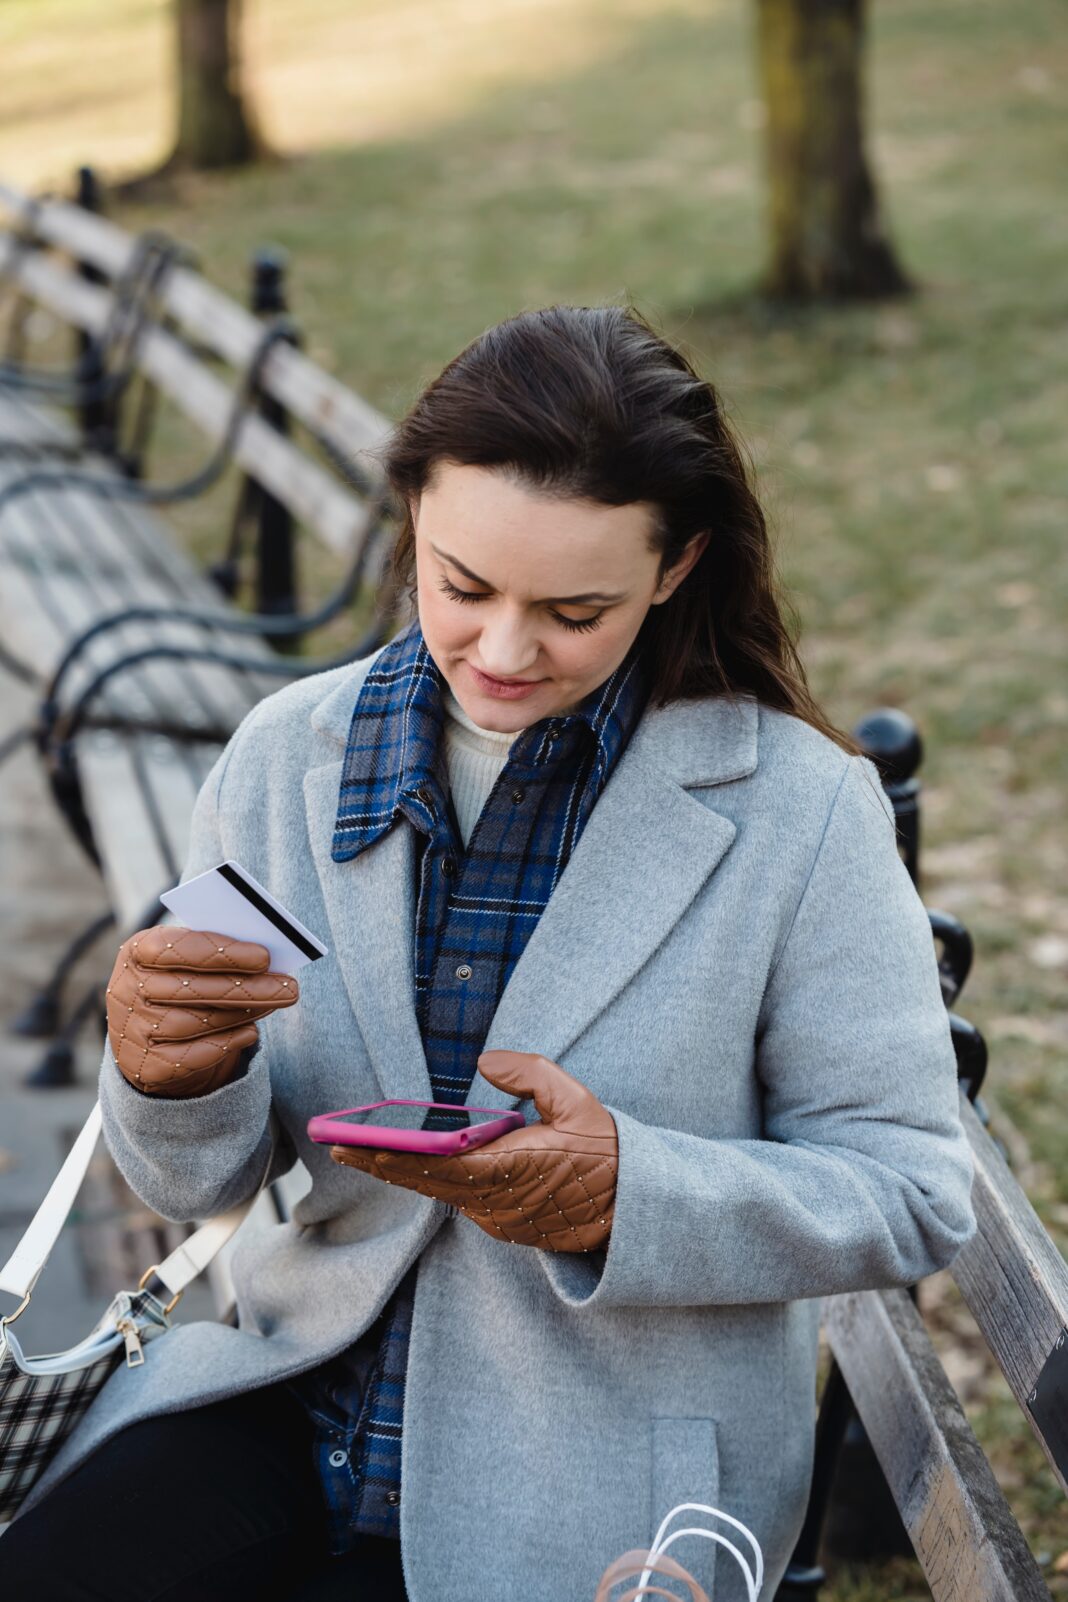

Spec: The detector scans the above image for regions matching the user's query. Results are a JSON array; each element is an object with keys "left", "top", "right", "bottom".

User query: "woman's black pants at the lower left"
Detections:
[{"left": 0, "top": 1386, "right": 407, "bottom": 1602}]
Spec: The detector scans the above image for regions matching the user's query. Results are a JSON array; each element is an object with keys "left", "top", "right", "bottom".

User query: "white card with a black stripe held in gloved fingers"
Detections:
[{"left": 160, "top": 862, "right": 330, "bottom": 974}]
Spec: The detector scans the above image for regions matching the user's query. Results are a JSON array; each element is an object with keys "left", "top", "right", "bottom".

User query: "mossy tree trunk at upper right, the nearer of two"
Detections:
[{"left": 757, "top": 0, "right": 911, "bottom": 301}]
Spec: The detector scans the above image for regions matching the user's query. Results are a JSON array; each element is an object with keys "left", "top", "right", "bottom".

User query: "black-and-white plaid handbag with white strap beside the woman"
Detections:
[{"left": 0, "top": 1102, "right": 274, "bottom": 1522}]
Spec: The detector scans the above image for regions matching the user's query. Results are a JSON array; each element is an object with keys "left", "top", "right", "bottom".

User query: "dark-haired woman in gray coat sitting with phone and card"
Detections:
[{"left": 0, "top": 306, "right": 974, "bottom": 1602}]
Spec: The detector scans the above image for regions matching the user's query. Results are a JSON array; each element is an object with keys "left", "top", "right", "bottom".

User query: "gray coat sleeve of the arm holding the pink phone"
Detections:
[{"left": 538, "top": 758, "right": 975, "bottom": 1306}]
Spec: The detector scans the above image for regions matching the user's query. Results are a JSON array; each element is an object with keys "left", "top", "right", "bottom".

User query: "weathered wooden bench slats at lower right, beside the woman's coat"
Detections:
[{"left": 825, "top": 1096, "right": 1068, "bottom": 1602}]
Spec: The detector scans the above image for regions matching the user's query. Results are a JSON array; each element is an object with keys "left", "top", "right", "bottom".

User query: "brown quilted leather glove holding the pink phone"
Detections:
[{"left": 330, "top": 1051, "right": 620, "bottom": 1251}]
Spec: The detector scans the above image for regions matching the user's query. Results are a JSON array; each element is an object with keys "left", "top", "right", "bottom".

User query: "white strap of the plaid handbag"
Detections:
[{"left": 0, "top": 1102, "right": 277, "bottom": 1323}]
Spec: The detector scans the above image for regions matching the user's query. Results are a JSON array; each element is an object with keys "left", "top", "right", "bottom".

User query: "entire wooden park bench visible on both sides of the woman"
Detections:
[{"left": 0, "top": 186, "right": 1068, "bottom": 1602}]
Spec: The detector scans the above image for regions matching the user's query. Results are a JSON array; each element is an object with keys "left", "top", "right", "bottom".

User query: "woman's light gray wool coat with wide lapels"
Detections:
[{"left": 14, "top": 657, "right": 975, "bottom": 1602}]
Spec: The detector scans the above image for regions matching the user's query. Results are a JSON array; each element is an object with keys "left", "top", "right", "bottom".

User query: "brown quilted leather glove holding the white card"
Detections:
[{"left": 107, "top": 926, "right": 299, "bottom": 1097}]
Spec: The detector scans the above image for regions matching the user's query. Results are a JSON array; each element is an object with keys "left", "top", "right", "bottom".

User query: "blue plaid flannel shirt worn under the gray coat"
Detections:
[{"left": 291, "top": 620, "right": 647, "bottom": 1554}]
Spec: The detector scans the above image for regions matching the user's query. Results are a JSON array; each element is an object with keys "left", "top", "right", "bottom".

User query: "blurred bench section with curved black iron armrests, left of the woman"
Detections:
[{"left": 0, "top": 175, "right": 392, "bottom": 1078}]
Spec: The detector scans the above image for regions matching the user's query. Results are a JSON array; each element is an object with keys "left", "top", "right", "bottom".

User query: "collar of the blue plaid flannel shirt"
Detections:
[{"left": 331, "top": 618, "right": 647, "bottom": 862}]
